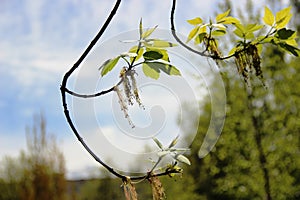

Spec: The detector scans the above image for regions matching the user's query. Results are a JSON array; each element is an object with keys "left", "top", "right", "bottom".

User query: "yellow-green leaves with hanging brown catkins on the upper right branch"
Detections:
[{"left": 186, "top": 7, "right": 300, "bottom": 83}]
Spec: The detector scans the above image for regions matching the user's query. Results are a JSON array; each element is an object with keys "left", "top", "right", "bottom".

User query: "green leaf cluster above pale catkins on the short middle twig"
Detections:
[{"left": 99, "top": 20, "right": 180, "bottom": 79}]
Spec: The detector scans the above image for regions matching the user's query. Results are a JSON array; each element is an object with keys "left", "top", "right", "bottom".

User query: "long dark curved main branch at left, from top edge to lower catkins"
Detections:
[{"left": 60, "top": 0, "right": 125, "bottom": 179}]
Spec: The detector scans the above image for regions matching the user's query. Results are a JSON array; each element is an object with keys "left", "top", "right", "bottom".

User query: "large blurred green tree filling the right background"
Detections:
[{"left": 182, "top": 0, "right": 300, "bottom": 199}]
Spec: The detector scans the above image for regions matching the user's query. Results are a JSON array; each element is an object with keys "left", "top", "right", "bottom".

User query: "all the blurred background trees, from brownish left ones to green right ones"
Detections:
[{"left": 0, "top": 0, "right": 300, "bottom": 200}]
